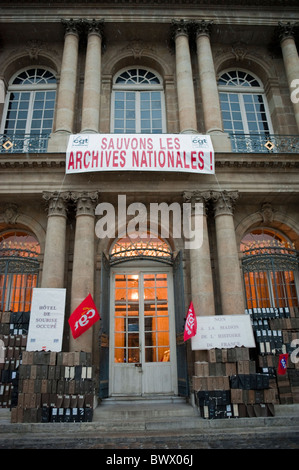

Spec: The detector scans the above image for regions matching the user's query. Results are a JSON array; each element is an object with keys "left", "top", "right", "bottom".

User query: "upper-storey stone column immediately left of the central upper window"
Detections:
[{"left": 81, "top": 20, "right": 103, "bottom": 133}]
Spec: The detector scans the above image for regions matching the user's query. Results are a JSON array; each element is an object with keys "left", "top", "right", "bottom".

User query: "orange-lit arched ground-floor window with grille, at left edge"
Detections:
[{"left": 0, "top": 230, "right": 40, "bottom": 323}]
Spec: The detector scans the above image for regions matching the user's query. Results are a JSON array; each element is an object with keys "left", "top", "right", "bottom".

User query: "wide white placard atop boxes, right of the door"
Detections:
[{"left": 191, "top": 314, "right": 255, "bottom": 350}]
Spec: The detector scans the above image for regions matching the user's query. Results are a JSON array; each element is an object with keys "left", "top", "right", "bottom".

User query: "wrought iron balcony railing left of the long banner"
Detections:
[{"left": 0, "top": 133, "right": 49, "bottom": 153}]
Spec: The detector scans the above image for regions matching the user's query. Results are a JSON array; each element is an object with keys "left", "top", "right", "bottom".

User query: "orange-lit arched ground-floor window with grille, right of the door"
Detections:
[{"left": 241, "top": 228, "right": 299, "bottom": 308}]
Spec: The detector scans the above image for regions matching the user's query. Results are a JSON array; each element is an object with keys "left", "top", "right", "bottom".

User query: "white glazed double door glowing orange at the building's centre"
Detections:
[{"left": 109, "top": 267, "right": 177, "bottom": 396}]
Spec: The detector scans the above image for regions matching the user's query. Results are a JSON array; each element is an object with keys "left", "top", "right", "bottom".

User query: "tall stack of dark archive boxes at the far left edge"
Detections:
[{"left": 0, "top": 312, "right": 27, "bottom": 408}]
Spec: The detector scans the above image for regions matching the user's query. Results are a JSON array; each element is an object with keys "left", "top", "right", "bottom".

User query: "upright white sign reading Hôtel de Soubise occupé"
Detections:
[{"left": 27, "top": 288, "right": 66, "bottom": 352}]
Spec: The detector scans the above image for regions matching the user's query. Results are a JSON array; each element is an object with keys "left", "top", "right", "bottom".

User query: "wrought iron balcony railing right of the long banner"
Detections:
[{"left": 230, "top": 134, "right": 299, "bottom": 154}]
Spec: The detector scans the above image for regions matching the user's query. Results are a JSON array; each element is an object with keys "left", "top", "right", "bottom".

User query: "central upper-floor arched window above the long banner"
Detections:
[{"left": 111, "top": 67, "right": 166, "bottom": 134}]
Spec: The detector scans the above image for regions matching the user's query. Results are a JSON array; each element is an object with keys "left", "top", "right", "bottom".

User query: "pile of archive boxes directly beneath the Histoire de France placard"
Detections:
[{"left": 193, "top": 347, "right": 276, "bottom": 419}]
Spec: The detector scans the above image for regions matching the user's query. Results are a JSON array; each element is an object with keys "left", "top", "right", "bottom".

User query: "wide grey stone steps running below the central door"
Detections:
[{"left": 0, "top": 403, "right": 299, "bottom": 436}]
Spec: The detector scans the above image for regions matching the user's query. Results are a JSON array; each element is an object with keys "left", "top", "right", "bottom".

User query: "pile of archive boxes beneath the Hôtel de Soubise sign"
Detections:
[{"left": 11, "top": 351, "right": 95, "bottom": 422}]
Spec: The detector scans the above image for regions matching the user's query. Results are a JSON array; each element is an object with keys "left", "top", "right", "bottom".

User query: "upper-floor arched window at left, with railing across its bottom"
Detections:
[{"left": 1, "top": 68, "right": 56, "bottom": 152}]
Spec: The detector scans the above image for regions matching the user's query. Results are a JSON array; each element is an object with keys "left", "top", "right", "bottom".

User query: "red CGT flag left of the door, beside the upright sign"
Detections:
[{"left": 69, "top": 294, "right": 100, "bottom": 339}]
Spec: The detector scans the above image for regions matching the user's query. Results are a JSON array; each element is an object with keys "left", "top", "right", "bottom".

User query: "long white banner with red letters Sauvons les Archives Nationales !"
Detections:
[{"left": 65, "top": 134, "right": 215, "bottom": 174}]
